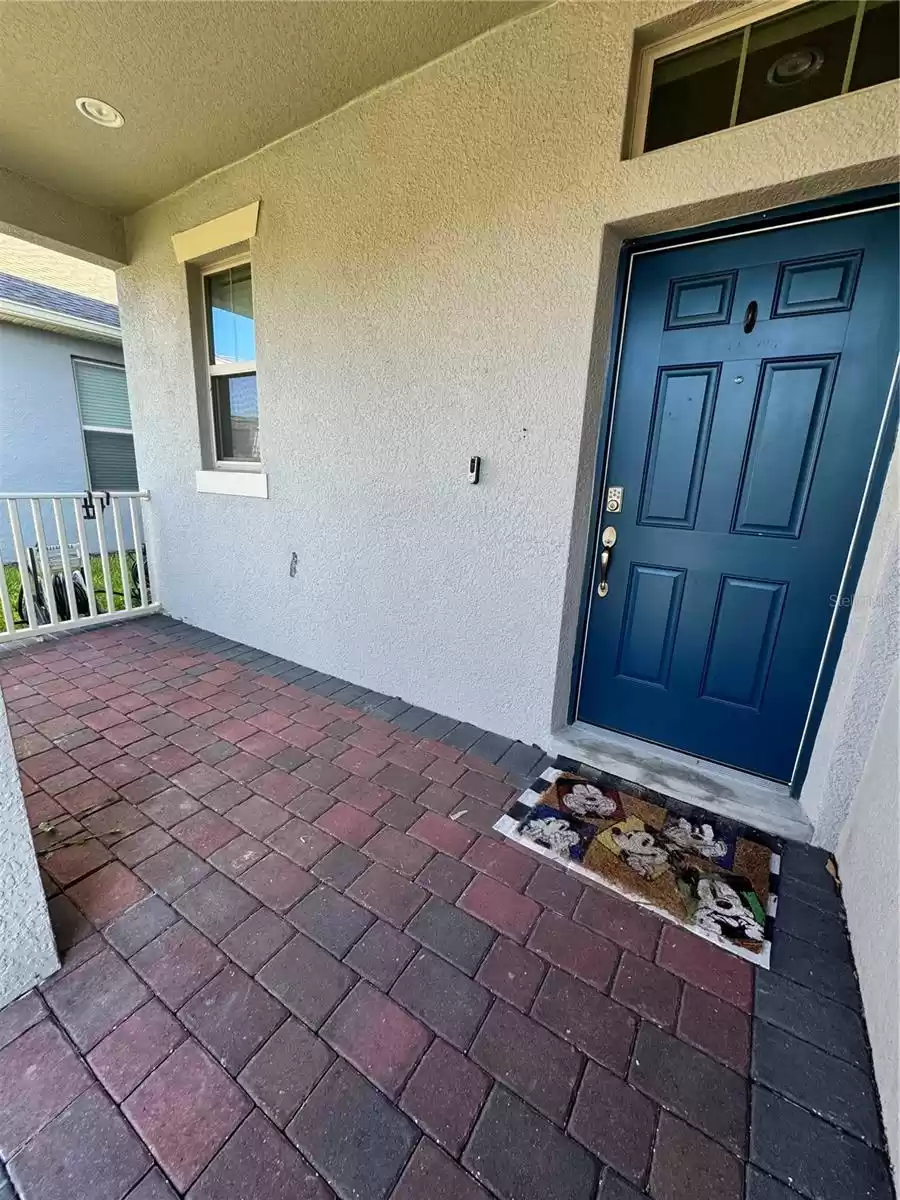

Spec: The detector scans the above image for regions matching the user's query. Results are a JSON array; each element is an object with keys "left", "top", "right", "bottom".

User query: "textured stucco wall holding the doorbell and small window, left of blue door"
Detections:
[{"left": 119, "top": 2, "right": 898, "bottom": 758}]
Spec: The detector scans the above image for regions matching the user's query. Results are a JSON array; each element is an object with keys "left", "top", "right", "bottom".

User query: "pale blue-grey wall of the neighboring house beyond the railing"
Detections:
[{"left": 0, "top": 322, "right": 124, "bottom": 560}]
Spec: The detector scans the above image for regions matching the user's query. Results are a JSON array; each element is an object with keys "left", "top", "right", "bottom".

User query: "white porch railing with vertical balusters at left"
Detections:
[{"left": 0, "top": 492, "right": 160, "bottom": 643}]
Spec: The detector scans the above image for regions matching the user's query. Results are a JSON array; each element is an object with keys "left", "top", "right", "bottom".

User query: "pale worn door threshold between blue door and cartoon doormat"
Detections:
[{"left": 551, "top": 721, "right": 812, "bottom": 841}]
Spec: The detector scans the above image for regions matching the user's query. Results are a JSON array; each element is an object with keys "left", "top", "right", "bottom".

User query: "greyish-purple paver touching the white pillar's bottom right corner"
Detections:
[{"left": 44, "top": 947, "right": 150, "bottom": 1051}]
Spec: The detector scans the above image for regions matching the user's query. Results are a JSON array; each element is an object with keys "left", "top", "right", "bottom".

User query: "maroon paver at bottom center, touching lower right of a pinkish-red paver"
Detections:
[{"left": 401, "top": 1038, "right": 491, "bottom": 1154}]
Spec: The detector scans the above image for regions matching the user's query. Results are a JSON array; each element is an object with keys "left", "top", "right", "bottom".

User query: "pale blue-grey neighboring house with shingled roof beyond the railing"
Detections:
[{"left": 0, "top": 271, "right": 138, "bottom": 562}]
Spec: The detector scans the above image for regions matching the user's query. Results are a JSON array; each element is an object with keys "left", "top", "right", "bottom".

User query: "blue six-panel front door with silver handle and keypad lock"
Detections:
[{"left": 576, "top": 209, "right": 898, "bottom": 780}]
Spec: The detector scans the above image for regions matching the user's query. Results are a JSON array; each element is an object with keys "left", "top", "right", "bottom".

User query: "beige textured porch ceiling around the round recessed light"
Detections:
[{"left": 0, "top": 0, "right": 540, "bottom": 214}]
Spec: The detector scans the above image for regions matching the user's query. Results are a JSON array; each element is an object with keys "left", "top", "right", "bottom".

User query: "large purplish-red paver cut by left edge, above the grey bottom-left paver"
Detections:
[{"left": 0, "top": 1021, "right": 91, "bottom": 1162}]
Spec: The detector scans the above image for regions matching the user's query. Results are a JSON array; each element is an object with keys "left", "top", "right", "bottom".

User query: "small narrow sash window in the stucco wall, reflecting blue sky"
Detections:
[{"left": 204, "top": 262, "right": 259, "bottom": 464}]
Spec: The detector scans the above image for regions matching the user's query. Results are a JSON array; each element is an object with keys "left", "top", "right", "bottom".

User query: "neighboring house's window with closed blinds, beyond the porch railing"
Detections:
[{"left": 72, "top": 359, "right": 138, "bottom": 492}]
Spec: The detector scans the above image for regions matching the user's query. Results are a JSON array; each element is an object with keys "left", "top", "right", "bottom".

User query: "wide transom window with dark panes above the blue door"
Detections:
[{"left": 631, "top": 0, "right": 900, "bottom": 155}]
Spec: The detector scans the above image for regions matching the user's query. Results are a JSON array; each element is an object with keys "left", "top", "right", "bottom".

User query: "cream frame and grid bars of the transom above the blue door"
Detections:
[{"left": 625, "top": 0, "right": 892, "bottom": 158}]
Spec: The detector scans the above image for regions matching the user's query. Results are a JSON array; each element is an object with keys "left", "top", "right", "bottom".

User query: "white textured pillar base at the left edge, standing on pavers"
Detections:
[{"left": 0, "top": 696, "right": 59, "bottom": 1008}]
